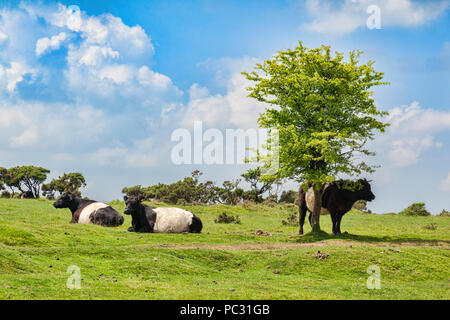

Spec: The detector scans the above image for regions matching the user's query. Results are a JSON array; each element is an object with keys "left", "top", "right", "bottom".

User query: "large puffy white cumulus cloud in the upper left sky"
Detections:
[{"left": 0, "top": 3, "right": 178, "bottom": 109}]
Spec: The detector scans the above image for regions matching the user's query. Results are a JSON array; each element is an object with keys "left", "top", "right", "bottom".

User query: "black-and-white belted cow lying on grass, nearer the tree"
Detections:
[{"left": 124, "top": 196, "right": 203, "bottom": 233}]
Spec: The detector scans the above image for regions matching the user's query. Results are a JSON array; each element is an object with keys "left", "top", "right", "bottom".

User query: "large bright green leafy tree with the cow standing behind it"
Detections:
[{"left": 243, "top": 42, "right": 388, "bottom": 232}]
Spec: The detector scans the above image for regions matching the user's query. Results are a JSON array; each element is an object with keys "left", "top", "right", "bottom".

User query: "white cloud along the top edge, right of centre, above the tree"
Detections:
[{"left": 301, "top": 0, "right": 450, "bottom": 34}]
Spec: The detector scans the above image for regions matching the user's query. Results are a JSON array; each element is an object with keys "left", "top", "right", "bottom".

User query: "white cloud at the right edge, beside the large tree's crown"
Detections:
[{"left": 377, "top": 102, "right": 450, "bottom": 166}]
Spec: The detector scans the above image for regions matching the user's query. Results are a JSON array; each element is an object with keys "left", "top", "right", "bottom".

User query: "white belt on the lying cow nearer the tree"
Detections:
[{"left": 153, "top": 208, "right": 194, "bottom": 233}]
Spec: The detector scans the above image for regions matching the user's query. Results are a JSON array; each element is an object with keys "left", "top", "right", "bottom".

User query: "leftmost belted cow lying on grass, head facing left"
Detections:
[{"left": 53, "top": 192, "right": 123, "bottom": 227}]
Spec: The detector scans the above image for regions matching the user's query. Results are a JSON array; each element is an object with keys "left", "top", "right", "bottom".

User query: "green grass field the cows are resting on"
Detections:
[{"left": 0, "top": 199, "right": 450, "bottom": 299}]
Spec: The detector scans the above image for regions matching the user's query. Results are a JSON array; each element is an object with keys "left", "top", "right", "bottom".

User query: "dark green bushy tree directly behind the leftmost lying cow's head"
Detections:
[{"left": 42, "top": 172, "right": 86, "bottom": 198}]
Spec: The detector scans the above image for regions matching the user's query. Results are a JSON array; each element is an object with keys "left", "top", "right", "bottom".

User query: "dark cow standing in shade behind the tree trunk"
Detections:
[{"left": 298, "top": 179, "right": 375, "bottom": 235}]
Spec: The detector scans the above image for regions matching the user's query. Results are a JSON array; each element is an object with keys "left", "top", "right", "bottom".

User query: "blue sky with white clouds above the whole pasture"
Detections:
[{"left": 0, "top": 0, "right": 450, "bottom": 213}]
